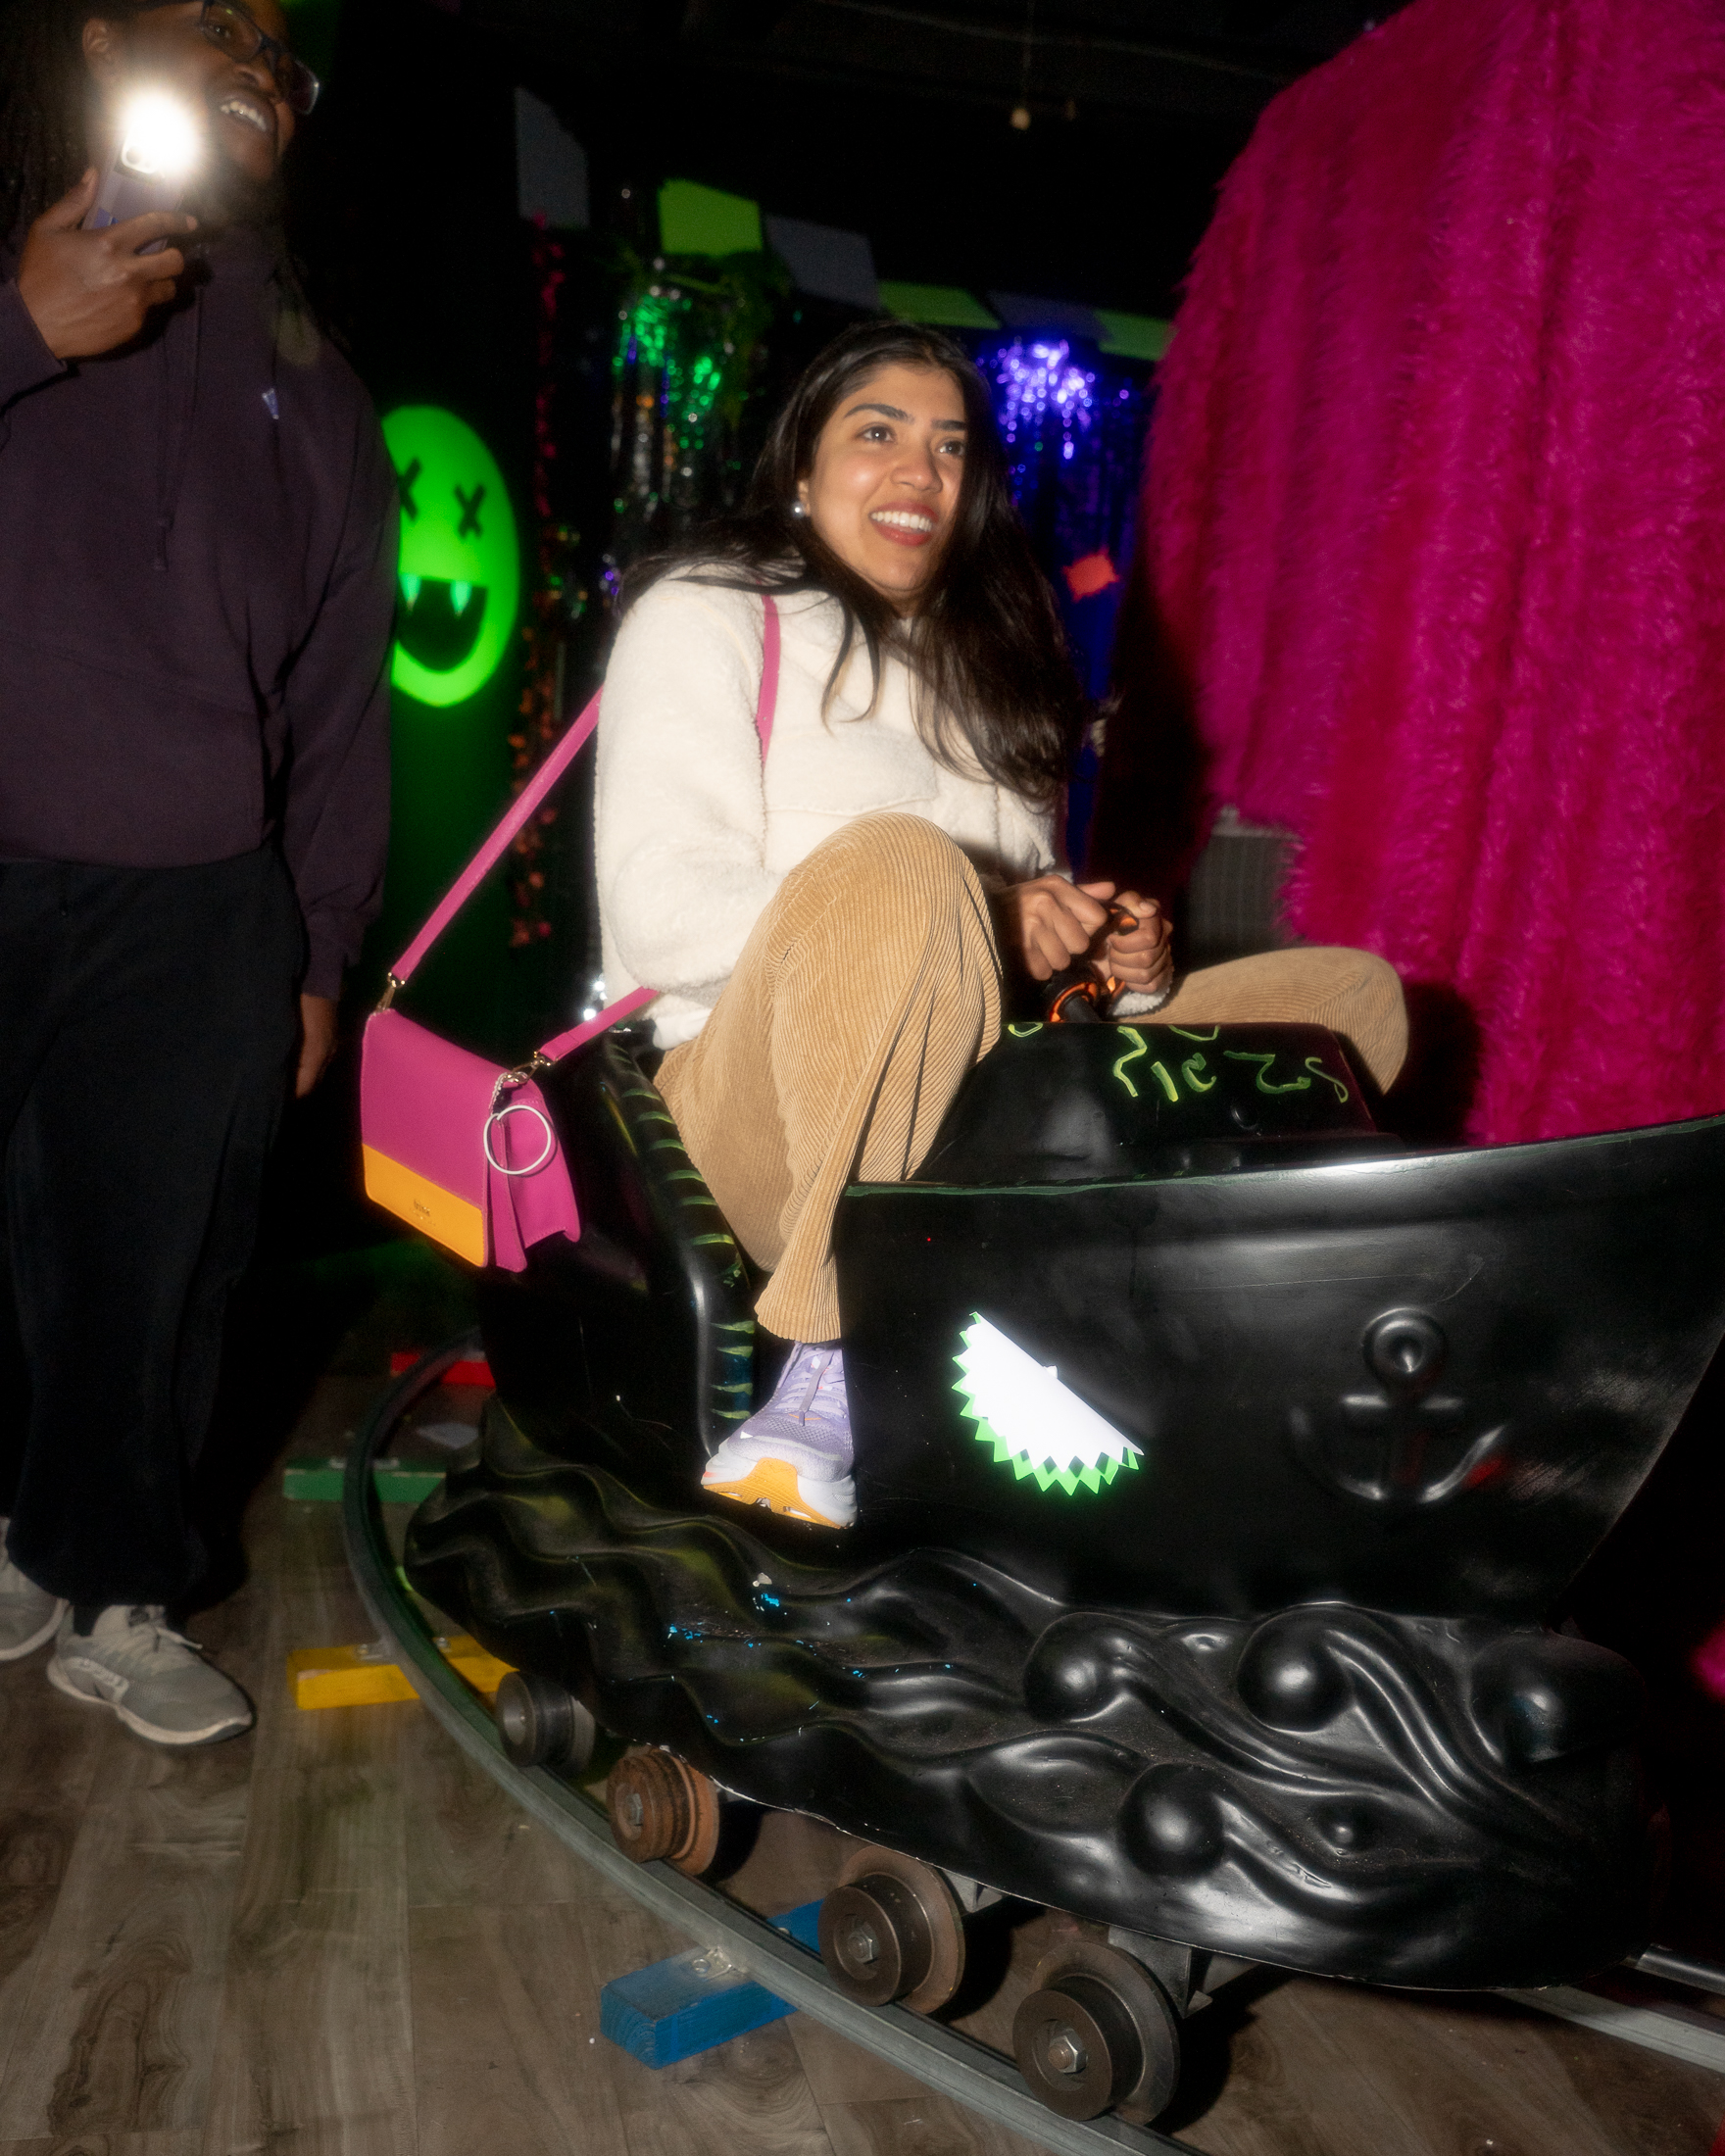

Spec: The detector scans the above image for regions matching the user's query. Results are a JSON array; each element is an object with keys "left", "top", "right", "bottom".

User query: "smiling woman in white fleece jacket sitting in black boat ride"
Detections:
[{"left": 597, "top": 323, "right": 1405, "bottom": 1527}]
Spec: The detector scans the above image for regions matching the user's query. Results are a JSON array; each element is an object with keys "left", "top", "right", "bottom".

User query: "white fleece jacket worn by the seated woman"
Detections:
[{"left": 595, "top": 575, "right": 1055, "bottom": 1048}]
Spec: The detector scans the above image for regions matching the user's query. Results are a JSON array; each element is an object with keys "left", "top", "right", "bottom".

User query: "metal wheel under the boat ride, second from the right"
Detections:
[{"left": 819, "top": 1847, "right": 963, "bottom": 2014}]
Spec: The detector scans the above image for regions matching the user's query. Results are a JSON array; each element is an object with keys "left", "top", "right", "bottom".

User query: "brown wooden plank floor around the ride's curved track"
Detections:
[{"left": 0, "top": 1258, "right": 1725, "bottom": 2156}]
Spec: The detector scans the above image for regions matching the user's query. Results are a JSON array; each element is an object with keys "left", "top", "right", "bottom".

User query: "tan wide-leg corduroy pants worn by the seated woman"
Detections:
[{"left": 658, "top": 815, "right": 1408, "bottom": 1341}]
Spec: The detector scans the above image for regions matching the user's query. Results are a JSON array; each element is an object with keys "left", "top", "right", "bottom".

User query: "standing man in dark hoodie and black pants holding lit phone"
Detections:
[{"left": 0, "top": 0, "right": 395, "bottom": 1744}]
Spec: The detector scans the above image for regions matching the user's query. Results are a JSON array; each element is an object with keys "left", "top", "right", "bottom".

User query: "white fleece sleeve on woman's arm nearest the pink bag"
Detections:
[{"left": 597, "top": 580, "right": 780, "bottom": 1006}]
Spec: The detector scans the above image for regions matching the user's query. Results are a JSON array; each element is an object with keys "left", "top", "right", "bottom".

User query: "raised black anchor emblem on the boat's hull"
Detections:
[{"left": 1287, "top": 1311, "right": 1507, "bottom": 1511}]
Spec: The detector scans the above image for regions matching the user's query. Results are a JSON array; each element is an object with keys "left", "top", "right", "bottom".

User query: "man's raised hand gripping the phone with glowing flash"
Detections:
[{"left": 18, "top": 166, "right": 198, "bottom": 360}]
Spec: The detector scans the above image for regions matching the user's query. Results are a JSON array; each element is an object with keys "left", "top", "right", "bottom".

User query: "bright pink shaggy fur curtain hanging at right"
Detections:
[{"left": 1100, "top": 0, "right": 1725, "bottom": 1141}]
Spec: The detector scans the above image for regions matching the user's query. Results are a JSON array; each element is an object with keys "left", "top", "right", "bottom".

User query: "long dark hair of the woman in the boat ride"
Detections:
[{"left": 625, "top": 321, "right": 1085, "bottom": 807}]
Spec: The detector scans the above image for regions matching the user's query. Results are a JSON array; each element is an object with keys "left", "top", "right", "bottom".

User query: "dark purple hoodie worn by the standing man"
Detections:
[{"left": 0, "top": 233, "right": 397, "bottom": 996}]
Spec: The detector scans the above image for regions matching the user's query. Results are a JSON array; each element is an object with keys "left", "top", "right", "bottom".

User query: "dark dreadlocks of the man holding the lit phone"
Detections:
[{"left": 0, "top": 0, "right": 162, "bottom": 239}]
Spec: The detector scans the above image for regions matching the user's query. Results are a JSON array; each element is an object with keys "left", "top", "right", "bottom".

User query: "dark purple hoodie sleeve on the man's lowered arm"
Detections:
[{"left": 282, "top": 408, "right": 399, "bottom": 996}]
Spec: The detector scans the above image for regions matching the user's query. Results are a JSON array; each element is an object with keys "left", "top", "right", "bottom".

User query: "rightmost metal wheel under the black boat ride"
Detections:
[{"left": 1011, "top": 1940, "right": 1179, "bottom": 2126}]
